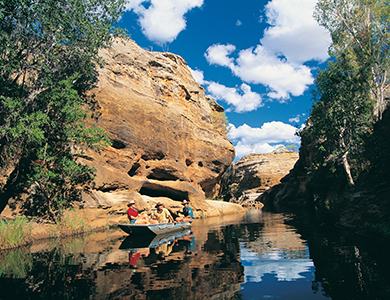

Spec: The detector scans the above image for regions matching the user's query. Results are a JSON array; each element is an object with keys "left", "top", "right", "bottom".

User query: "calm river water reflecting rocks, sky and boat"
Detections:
[{"left": 0, "top": 210, "right": 390, "bottom": 300}]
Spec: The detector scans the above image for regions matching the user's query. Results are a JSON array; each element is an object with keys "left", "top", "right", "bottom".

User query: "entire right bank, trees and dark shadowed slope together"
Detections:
[{"left": 282, "top": 0, "right": 390, "bottom": 238}]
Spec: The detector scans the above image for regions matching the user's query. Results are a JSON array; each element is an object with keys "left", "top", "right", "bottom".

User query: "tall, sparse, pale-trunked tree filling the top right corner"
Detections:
[{"left": 314, "top": 0, "right": 390, "bottom": 119}]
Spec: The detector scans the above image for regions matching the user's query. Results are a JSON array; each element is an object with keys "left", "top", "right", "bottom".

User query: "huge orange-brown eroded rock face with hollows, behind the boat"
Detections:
[{"left": 78, "top": 40, "right": 235, "bottom": 213}]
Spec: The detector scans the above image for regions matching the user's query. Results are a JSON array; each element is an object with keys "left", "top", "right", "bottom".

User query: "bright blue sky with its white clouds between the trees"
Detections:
[{"left": 119, "top": 0, "right": 330, "bottom": 159}]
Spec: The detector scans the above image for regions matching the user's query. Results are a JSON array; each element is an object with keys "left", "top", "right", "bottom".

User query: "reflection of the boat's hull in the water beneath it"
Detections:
[{"left": 119, "top": 229, "right": 191, "bottom": 251}]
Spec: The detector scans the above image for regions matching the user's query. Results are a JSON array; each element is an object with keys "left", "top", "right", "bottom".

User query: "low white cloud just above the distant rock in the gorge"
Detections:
[{"left": 228, "top": 121, "right": 300, "bottom": 159}]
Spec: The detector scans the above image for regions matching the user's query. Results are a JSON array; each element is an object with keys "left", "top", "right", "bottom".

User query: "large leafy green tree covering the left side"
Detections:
[{"left": 0, "top": 0, "right": 124, "bottom": 221}]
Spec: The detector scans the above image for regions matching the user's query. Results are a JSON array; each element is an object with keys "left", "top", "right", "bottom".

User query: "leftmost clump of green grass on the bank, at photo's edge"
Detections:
[{"left": 0, "top": 217, "right": 33, "bottom": 250}]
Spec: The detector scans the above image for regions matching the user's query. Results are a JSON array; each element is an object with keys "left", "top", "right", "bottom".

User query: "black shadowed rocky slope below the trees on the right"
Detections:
[{"left": 260, "top": 109, "right": 390, "bottom": 241}]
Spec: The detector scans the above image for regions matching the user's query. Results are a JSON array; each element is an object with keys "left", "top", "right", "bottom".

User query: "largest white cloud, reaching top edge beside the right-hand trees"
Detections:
[{"left": 205, "top": 0, "right": 330, "bottom": 102}]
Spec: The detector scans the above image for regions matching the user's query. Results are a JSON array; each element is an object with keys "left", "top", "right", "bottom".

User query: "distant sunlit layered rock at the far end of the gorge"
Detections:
[{"left": 225, "top": 152, "right": 298, "bottom": 203}]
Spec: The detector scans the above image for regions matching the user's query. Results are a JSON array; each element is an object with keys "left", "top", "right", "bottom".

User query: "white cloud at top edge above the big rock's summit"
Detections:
[{"left": 126, "top": 0, "right": 203, "bottom": 45}]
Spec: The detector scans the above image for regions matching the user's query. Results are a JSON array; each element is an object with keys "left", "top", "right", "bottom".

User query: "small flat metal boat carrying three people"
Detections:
[{"left": 119, "top": 222, "right": 191, "bottom": 236}]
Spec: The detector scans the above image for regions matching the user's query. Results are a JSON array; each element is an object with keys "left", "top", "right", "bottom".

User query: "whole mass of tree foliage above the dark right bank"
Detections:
[{"left": 299, "top": 0, "right": 390, "bottom": 189}]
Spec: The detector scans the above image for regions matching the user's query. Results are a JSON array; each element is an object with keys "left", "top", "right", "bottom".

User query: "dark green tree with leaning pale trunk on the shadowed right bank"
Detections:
[{"left": 299, "top": 57, "right": 373, "bottom": 186}]
